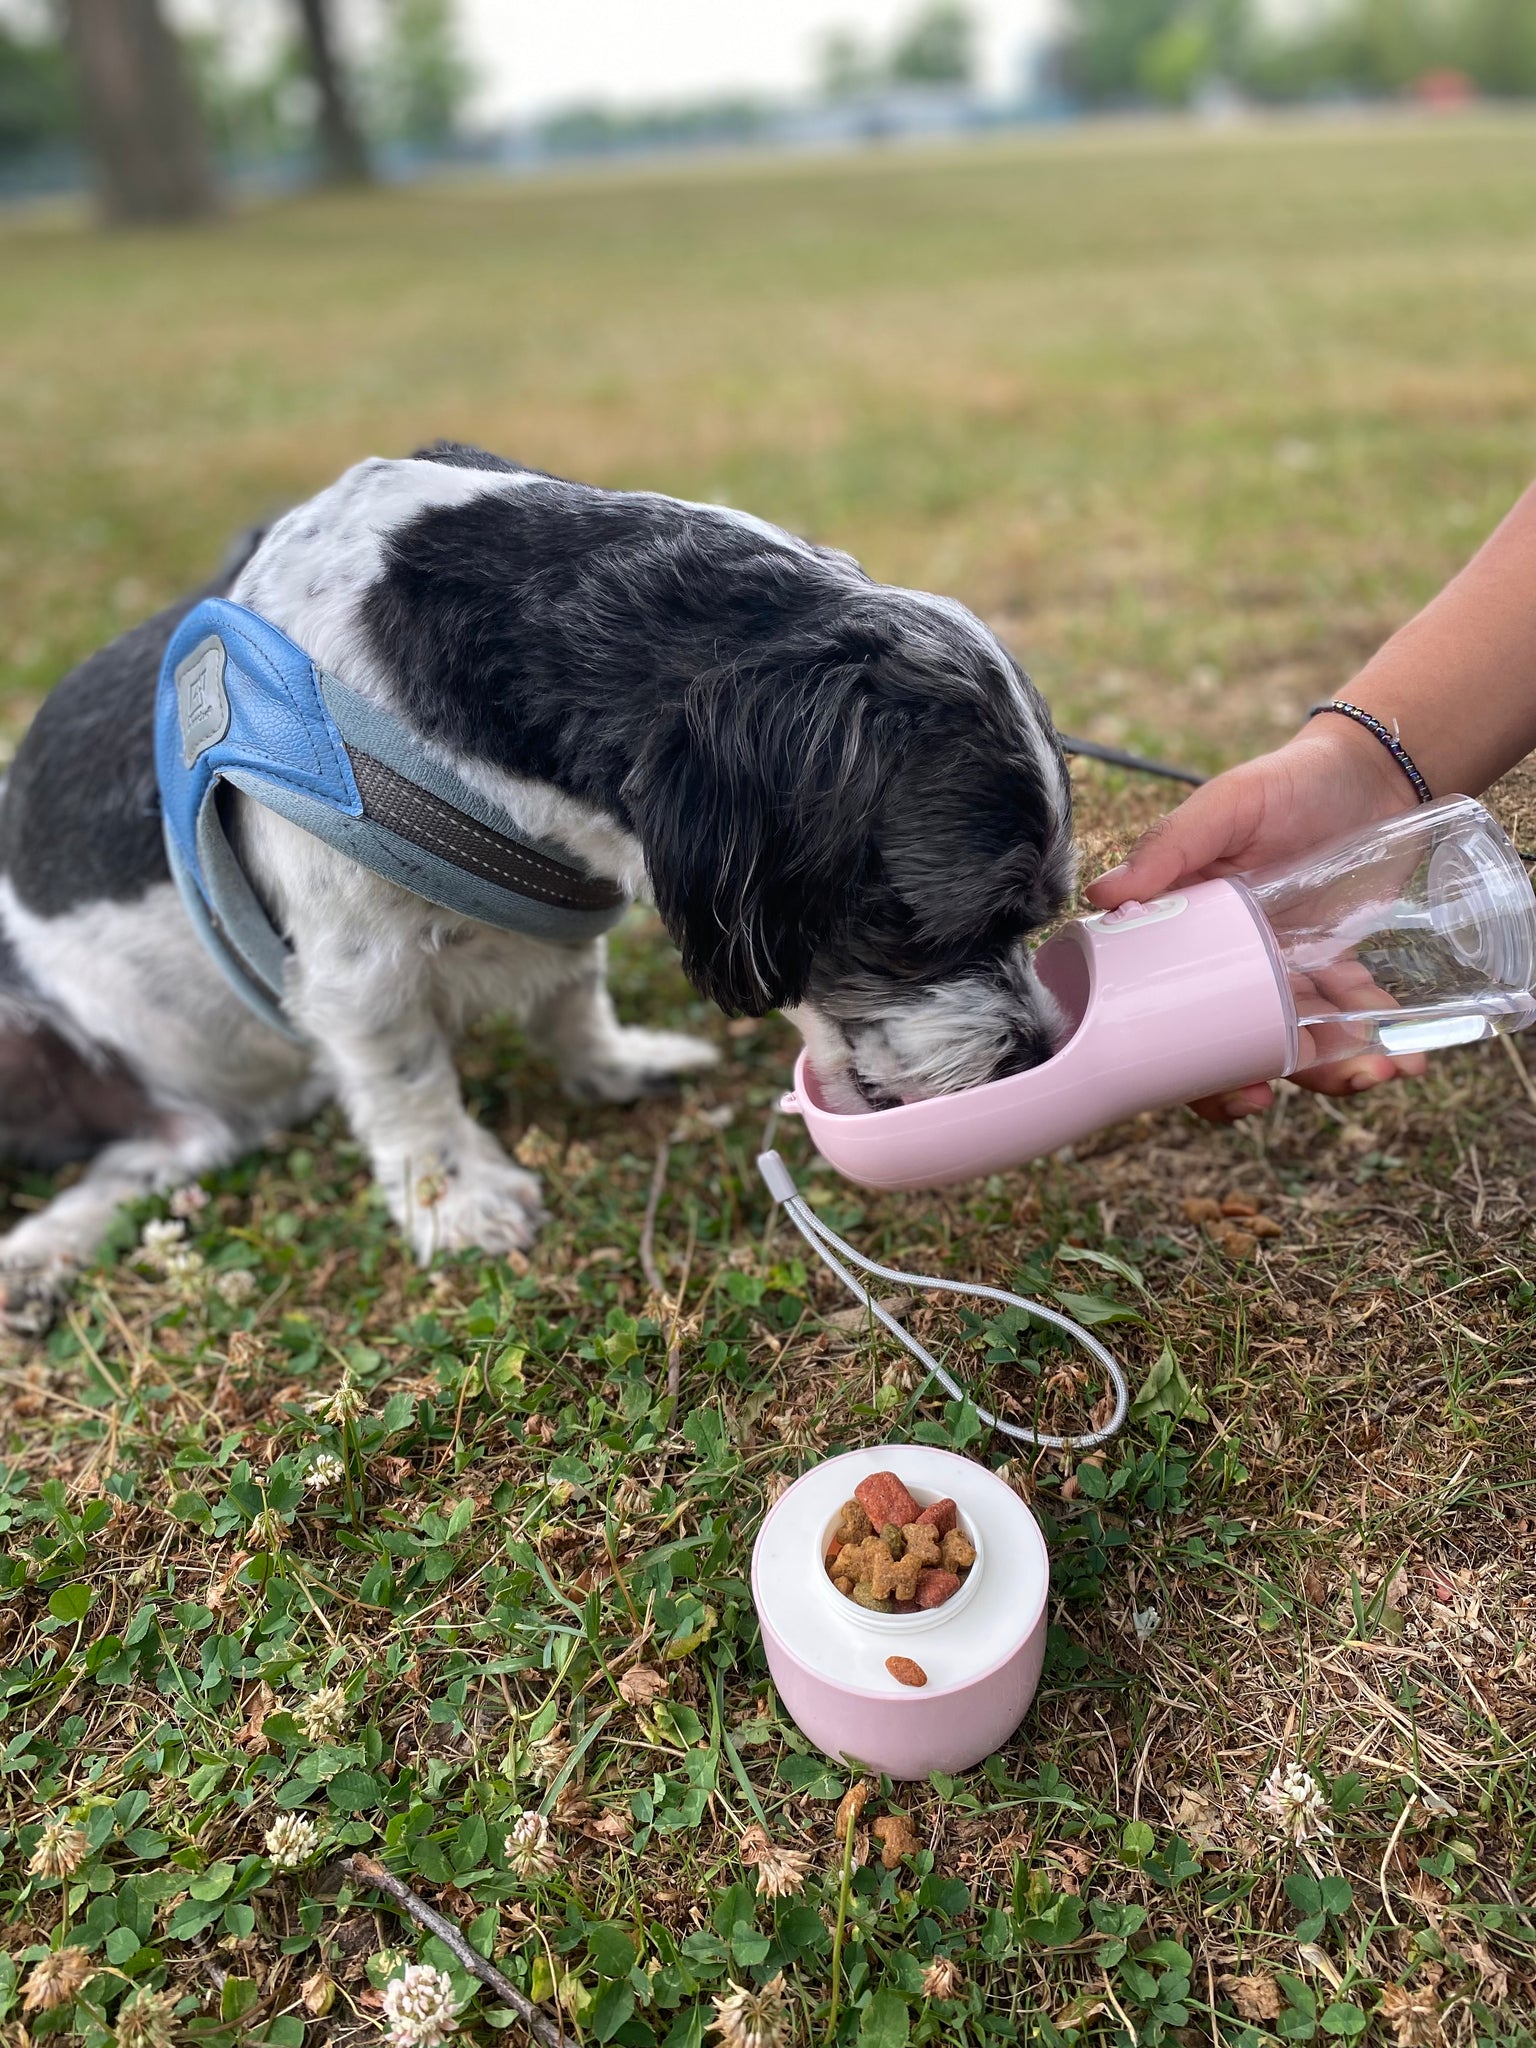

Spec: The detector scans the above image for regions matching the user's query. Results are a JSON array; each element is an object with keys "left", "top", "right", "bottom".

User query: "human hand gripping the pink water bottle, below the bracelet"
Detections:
[{"left": 1085, "top": 717, "right": 1425, "bottom": 1122}]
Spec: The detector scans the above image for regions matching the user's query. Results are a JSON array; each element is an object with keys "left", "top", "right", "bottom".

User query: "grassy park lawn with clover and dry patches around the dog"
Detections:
[{"left": 0, "top": 117, "right": 1536, "bottom": 2048}]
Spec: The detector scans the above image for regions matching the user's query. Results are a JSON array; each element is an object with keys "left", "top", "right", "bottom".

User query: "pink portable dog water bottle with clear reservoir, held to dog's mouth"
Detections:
[{"left": 784, "top": 797, "right": 1536, "bottom": 1188}]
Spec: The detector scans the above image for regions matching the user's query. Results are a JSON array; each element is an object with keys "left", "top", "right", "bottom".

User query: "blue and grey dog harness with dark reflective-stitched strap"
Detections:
[{"left": 156, "top": 598, "right": 629, "bottom": 1038}]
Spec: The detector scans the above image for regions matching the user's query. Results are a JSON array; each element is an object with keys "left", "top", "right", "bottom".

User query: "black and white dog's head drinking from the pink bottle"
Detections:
[{"left": 625, "top": 585, "right": 1073, "bottom": 1110}]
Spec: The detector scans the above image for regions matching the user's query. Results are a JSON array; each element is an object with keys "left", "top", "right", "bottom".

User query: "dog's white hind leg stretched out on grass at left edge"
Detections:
[{"left": 0, "top": 1114, "right": 250, "bottom": 1335}]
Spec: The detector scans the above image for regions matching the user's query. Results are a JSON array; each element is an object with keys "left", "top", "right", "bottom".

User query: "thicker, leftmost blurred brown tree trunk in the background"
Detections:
[{"left": 66, "top": 0, "right": 217, "bottom": 223}]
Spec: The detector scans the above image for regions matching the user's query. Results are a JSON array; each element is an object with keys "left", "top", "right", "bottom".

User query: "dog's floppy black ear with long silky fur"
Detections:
[{"left": 625, "top": 666, "right": 889, "bottom": 1016}]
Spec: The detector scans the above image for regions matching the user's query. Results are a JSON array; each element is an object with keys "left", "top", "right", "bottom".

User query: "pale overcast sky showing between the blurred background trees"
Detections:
[{"left": 138, "top": 0, "right": 1055, "bottom": 121}]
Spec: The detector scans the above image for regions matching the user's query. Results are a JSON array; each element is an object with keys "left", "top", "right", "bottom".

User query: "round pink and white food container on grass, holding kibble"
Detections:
[{"left": 752, "top": 1444, "right": 1051, "bottom": 1778}]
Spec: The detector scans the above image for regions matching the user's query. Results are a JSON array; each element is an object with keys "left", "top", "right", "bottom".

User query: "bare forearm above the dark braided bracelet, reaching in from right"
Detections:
[{"left": 1327, "top": 485, "right": 1536, "bottom": 797}]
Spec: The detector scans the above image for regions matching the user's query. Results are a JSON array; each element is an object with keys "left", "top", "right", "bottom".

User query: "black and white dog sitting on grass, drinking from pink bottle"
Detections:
[{"left": 0, "top": 444, "right": 1073, "bottom": 1329}]
